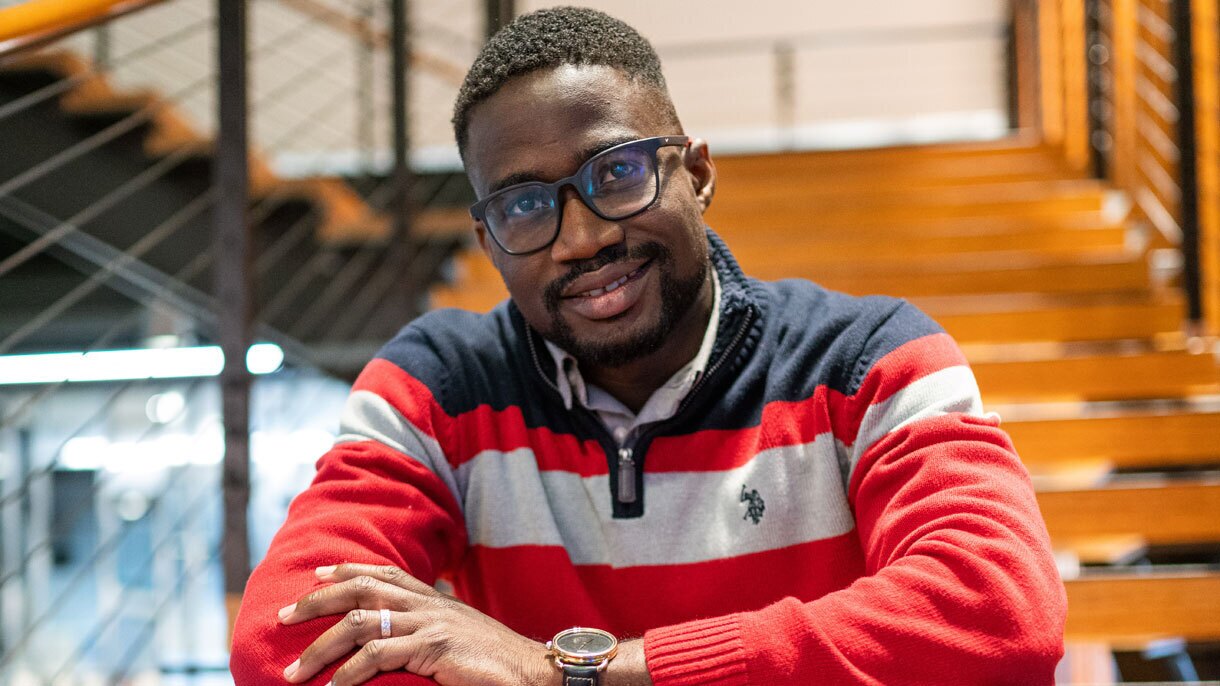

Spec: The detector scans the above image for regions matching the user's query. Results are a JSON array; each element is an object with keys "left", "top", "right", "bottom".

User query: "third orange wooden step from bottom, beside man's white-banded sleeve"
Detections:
[{"left": 1003, "top": 410, "right": 1220, "bottom": 466}]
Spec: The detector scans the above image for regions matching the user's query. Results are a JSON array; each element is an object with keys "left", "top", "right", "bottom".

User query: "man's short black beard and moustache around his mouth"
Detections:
[{"left": 540, "top": 243, "right": 711, "bottom": 367}]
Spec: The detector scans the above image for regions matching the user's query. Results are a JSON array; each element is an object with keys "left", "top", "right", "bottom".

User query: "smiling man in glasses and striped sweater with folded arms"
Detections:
[{"left": 233, "top": 7, "right": 1065, "bottom": 686}]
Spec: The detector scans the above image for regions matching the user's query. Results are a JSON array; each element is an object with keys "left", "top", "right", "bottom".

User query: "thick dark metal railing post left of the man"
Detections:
[{"left": 212, "top": 0, "right": 253, "bottom": 632}]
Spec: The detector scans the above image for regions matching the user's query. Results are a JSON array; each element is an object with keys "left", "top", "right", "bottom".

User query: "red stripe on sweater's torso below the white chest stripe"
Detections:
[{"left": 454, "top": 531, "right": 864, "bottom": 640}]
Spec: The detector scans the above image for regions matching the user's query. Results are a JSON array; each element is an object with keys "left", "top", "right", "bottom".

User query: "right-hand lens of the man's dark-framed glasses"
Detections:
[{"left": 581, "top": 145, "right": 656, "bottom": 218}]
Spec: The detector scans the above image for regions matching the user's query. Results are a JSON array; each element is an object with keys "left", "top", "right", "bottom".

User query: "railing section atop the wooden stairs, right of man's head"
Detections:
[{"left": 658, "top": 17, "right": 1013, "bottom": 150}]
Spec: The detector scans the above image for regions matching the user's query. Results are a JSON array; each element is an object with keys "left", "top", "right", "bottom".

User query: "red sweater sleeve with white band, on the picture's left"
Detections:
[{"left": 231, "top": 360, "right": 466, "bottom": 686}]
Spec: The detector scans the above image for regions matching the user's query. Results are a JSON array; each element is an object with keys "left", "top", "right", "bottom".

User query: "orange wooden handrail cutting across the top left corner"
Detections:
[{"left": 0, "top": 0, "right": 163, "bottom": 59}]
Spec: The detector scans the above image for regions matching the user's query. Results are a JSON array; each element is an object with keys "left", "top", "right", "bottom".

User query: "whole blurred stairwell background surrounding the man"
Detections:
[{"left": 0, "top": 0, "right": 1220, "bottom": 685}]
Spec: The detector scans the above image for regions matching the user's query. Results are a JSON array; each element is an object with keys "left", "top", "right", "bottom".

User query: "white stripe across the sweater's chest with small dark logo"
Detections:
[{"left": 459, "top": 433, "right": 855, "bottom": 568}]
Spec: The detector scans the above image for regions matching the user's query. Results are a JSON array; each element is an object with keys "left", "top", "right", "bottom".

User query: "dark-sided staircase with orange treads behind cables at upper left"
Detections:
[{"left": 0, "top": 50, "right": 468, "bottom": 377}]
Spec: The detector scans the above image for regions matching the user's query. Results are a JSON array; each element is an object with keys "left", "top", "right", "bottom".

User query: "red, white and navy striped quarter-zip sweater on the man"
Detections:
[{"left": 232, "top": 232, "right": 1065, "bottom": 685}]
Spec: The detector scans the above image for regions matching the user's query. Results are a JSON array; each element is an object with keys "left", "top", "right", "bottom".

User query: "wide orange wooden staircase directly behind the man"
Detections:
[{"left": 433, "top": 139, "right": 1220, "bottom": 668}]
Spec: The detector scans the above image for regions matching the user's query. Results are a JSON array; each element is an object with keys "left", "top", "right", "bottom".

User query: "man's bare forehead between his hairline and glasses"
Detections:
[{"left": 466, "top": 65, "right": 678, "bottom": 197}]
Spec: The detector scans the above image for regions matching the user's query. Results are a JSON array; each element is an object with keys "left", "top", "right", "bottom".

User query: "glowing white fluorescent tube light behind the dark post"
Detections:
[{"left": 0, "top": 343, "right": 284, "bottom": 386}]
